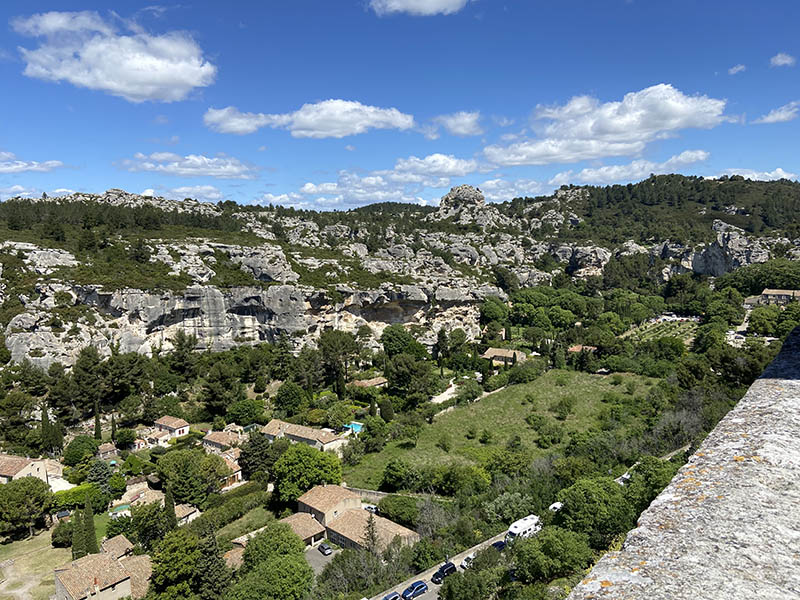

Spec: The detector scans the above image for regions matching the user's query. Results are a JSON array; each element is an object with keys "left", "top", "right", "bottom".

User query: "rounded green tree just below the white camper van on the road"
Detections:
[{"left": 513, "top": 527, "right": 592, "bottom": 583}]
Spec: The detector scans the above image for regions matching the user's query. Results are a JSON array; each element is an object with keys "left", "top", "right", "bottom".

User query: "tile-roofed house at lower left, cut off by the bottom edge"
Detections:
[{"left": 55, "top": 554, "right": 133, "bottom": 600}]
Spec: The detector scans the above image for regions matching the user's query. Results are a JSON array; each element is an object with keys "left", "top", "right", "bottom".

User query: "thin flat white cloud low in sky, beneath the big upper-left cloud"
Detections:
[{"left": 120, "top": 152, "right": 256, "bottom": 179}]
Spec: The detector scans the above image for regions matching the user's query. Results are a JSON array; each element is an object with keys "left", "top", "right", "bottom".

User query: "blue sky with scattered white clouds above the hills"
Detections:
[{"left": 0, "top": 0, "right": 800, "bottom": 209}]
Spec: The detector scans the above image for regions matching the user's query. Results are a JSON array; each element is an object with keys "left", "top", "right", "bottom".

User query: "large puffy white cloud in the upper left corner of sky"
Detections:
[{"left": 11, "top": 11, "right": 217, "bottom": 102}]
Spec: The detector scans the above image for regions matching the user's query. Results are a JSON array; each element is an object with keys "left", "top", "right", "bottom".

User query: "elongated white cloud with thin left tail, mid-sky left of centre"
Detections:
[{"left": 203, "top": 100, "right": 414, "bottom": 138}]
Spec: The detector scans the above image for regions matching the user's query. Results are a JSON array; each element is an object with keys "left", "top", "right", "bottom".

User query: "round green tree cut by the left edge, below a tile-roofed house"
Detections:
[{"left": 0, "top": 477, "right": 53, "bottom": 535}]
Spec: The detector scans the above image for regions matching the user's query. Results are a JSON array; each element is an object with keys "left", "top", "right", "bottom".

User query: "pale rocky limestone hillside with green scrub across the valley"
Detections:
[{"left": 0, "top": 176, "right": 800, "bottom": 366}]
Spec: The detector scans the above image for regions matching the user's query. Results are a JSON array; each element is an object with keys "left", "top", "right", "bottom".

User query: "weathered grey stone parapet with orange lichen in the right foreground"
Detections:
[{"left": 568, "top": 328, "right": 800, "bottom": 600}]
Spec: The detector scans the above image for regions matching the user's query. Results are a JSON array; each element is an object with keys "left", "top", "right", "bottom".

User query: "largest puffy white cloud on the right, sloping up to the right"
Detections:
[{"left": 484, "top": 84, "right": 726, "bottom": 165}]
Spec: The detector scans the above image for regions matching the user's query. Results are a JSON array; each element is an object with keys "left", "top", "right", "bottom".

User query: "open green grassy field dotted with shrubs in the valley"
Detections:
[{"left": 344, "top": 370, "right": 657, "bottom": 489}]
